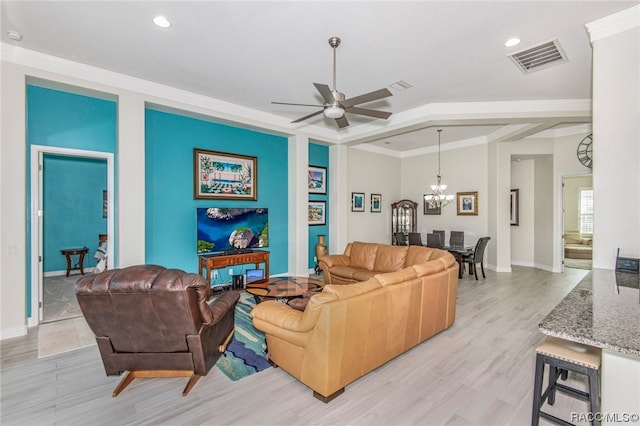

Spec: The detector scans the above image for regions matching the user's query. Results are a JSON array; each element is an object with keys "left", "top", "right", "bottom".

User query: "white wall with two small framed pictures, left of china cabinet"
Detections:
[{"left": 338, "top": 147, "right": 400, "bottom": 245}]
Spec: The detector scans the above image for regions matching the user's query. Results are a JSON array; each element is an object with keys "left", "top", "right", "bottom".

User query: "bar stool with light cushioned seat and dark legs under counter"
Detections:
[{"left": 531, "top": 337, "right": 602, "bottom": 425}]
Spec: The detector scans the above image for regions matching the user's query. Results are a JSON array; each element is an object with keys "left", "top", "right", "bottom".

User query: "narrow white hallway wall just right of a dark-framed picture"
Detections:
[{"left": 511, "top": 159, "right": 535, "bottom": 267}]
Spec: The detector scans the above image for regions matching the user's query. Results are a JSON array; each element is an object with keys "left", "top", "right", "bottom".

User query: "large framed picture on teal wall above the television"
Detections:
[{"left": 193, "top": 148, "right": 258, "bottom": 201}]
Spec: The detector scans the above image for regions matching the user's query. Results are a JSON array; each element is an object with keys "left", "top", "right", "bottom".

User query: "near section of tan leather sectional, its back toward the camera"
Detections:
[{"left": 252, "top": 245, "right": 458, "bottom": 402}]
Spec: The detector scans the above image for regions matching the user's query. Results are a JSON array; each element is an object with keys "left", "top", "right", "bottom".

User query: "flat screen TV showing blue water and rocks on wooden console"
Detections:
[{"left": 196, "top": 207, "right": 269, "bottom": 254}]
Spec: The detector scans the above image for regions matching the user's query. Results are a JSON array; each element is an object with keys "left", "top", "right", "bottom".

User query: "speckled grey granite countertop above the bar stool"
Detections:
[{"left": 539, "top": 269, "right": 640, "bottom": 358}]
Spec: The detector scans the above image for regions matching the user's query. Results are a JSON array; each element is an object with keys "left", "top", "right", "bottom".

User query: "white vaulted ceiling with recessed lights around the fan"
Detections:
[{"left": 1, "top": 0, "right": 638, "bottom": 151}]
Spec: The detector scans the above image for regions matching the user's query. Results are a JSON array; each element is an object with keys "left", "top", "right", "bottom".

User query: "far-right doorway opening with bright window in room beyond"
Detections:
[{"left": 562, "top": 174, "right": 593, "bottom": 270}]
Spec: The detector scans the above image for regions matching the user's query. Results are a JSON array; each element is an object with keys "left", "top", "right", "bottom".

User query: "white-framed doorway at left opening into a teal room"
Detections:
[{"left": 29, "top": 145, "right": 115, "bottom": 326}]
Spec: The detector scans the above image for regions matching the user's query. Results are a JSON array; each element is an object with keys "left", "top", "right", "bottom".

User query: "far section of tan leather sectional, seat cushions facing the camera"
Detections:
[{"left": 318, "top": 241, "right": 451, "bottom": 284}]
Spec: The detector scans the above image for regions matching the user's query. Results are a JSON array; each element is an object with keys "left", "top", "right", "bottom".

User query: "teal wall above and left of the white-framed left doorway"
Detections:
[{"left": 25, "top": 84, "right": 117, "bottom": 316}]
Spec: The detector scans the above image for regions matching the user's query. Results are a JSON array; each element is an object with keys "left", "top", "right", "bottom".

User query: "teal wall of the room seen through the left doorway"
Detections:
[{"left": 42, "top": 154, "right": 107, "bottom": 273}]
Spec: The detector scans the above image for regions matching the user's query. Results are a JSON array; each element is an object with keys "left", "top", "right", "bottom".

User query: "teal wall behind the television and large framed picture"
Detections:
[{"left": 144, "top": 109, "right": 289, "bottom": 282}]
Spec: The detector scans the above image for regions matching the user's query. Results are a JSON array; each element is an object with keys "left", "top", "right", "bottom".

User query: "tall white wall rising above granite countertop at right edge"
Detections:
[{"left": 592, "top": 24, "right": 640, "bottom": 269}]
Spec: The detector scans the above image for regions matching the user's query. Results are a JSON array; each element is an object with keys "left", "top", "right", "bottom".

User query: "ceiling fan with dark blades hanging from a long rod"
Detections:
[{"left": 271, "top": 37, "right": 393, "bottom": 128}]
